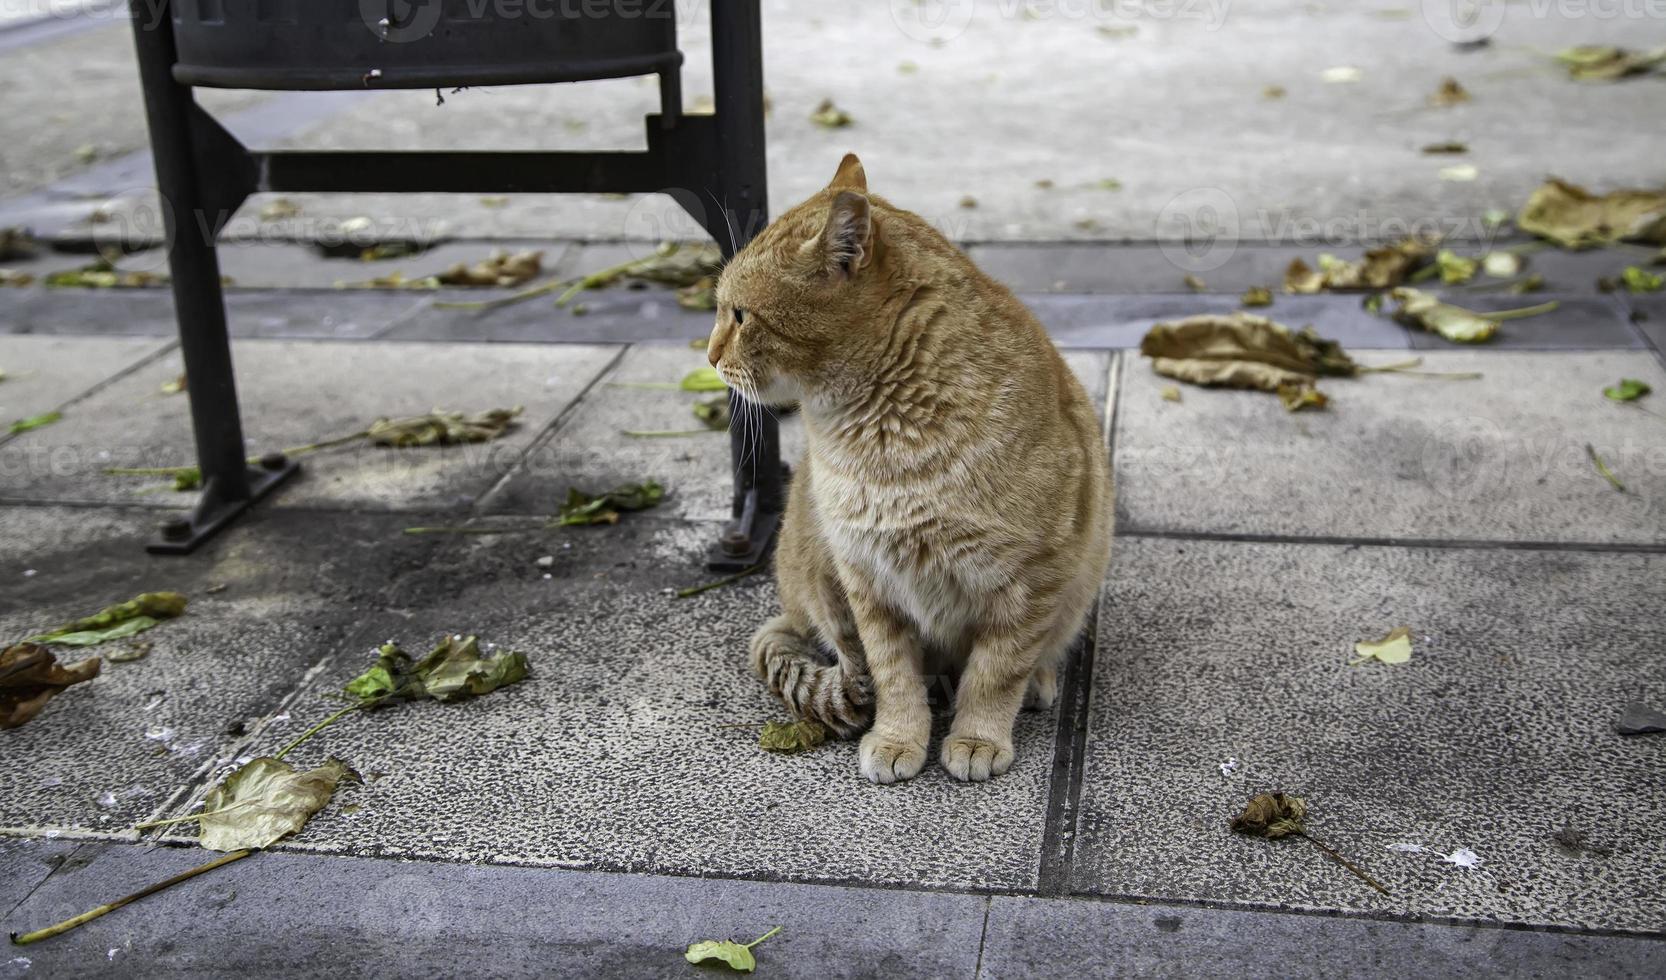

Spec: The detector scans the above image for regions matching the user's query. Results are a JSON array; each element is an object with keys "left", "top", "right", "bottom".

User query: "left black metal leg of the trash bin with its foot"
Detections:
[{"left": 132, "top": 0, "right": 297, "bottom": 555}]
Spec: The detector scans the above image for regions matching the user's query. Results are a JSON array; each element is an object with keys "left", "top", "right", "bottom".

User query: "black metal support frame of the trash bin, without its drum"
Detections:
[{"left": 128, "top": 0, "right": 781, "bottom": 567}]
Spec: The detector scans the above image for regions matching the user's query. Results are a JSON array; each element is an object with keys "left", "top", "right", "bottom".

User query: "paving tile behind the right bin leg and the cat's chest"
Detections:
[{"left": 485, "top": 343, "right": 1110, "bottom": 520}]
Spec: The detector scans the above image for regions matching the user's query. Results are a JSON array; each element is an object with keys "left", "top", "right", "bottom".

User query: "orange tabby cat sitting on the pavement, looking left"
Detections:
[{"left": 706, "top": 155, "right": 1111, "bottom": 783}]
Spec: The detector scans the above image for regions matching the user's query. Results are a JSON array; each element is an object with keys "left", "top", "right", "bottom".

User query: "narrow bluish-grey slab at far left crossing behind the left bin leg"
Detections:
[{"left": 0, "top": 287, "right": 426, "bottom": 340}]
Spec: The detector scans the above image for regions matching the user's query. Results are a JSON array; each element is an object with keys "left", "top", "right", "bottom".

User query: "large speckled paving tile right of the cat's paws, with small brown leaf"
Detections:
[{"left": 1075, "top": 538, "right": 1666, "bottom": 932}]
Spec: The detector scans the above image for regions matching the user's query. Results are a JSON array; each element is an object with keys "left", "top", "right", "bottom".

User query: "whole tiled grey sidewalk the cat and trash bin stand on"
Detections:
[{"left": 0, "top": 245, "right": 1666, "bottom": 977}]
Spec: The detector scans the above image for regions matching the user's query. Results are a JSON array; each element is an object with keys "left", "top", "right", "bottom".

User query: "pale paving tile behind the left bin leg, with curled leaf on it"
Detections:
[{"left": 0, "top": 340, "right": 623, "bottom": 510}]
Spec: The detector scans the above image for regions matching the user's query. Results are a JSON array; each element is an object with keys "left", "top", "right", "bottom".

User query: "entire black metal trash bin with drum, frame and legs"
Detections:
[{"left": 130, "top": 0, "right": 783, "bottom": 570}]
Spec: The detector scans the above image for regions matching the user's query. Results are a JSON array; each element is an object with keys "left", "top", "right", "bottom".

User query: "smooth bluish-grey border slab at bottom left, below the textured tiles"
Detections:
[{"left": 0, "top": 845, "right": 985, "bottom": 978}]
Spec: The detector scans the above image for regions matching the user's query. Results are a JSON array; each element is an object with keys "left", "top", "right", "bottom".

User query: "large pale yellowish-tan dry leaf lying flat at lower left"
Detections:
[{"left": 197, "top": 757, "right": 360, "bottom": 850}]
